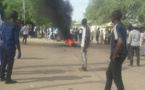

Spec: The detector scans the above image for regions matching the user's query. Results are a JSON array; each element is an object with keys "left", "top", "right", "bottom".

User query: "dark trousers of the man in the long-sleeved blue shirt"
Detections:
[{"left": 1, "top": 48, "right": 15, "bottom": 80}]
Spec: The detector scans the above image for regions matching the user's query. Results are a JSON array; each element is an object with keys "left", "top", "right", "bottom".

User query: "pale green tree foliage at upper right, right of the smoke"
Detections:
[{"left": 85, "top": 0, "right": 145, "bottom": 24}]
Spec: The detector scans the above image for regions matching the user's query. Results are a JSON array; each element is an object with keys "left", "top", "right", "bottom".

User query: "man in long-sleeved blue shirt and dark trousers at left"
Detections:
[{"left": 1, "top": 11, "right": 21, "bottom": 84}]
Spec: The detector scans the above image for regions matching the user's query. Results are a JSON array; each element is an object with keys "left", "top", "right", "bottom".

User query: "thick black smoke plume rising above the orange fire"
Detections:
[{"left": 42, "top": 0, "right": 73, "bottom": 40}]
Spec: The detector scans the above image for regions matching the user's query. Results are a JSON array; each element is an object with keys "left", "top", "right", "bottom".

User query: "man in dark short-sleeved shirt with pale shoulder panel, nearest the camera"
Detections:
[{"left": 105, "top": 10, "right": 127, "bottom": 90}]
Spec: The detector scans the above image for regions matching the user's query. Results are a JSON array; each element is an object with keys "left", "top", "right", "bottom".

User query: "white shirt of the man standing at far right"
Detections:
[{"left": 128, "top": 30, "right": 140, "bottom": 46}]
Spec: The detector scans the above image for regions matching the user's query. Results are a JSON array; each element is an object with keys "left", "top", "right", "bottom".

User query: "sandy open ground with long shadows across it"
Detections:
[{"left": 0, "top": 39, "right": 145, "bottom": 90}]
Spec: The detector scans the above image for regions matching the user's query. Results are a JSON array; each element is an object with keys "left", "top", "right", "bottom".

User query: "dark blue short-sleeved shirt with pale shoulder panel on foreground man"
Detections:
[{"left": 110, "top": 22, "right": 127, "bottom": 59}]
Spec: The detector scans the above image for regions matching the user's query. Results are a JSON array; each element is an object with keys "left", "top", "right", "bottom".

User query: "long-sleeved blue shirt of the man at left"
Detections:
[{"left": 1, "top": 22, "right": 20, "bottom": 52}]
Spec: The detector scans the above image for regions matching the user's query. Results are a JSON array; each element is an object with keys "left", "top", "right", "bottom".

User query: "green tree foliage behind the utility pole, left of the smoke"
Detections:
[{"left": 0, "top": 0, "right": 50, "bottom": 25}]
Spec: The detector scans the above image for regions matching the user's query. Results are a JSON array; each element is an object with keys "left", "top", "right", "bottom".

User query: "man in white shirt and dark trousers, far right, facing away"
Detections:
[{"left": 128, "top": 24, "right": 140, "bottom": 66}]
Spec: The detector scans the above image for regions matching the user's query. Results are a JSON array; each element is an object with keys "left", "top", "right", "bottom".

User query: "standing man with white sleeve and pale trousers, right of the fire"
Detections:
[{"left": 80, "top": 19, "right": 90, "bottom": 71}]
